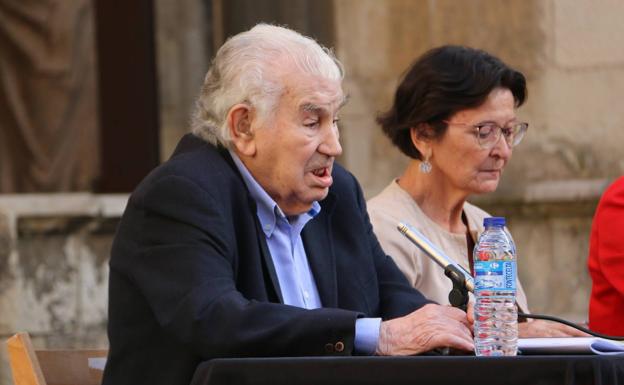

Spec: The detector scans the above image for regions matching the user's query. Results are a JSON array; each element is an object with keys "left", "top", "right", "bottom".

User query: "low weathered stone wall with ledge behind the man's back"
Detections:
[{"left": 0, "top": 194, "right": 127, "bottom": 385}]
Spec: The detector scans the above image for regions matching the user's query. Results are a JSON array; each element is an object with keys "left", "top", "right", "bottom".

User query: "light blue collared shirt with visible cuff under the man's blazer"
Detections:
[{"left": 230, "top": 151, "right": 381, "bottom": 354}]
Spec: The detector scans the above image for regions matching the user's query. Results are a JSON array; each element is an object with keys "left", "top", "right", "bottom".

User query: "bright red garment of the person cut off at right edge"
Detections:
[{"left": 587, "top": 177, "right": 624, "bottom": 336}]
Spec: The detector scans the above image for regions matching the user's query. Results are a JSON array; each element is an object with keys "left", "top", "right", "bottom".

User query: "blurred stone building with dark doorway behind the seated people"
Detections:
[{"left": 0, "top": 0, "right": 624, "bottom": 385}]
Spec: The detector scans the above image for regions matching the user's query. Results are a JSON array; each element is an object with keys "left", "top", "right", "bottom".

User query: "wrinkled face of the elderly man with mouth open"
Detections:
[{"left": 243, "top": 74, "right": 344, "bottom": 215}]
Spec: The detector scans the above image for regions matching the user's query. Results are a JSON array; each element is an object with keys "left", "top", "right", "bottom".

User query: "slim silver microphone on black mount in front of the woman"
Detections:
[{"left": 397, "top": 222, "right": 474, "bottom": 308}]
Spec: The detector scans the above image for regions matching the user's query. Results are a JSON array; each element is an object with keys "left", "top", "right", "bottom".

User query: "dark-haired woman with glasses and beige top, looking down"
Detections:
[{"left": 368, "top": 46, "right": 583, "bottom": 337}]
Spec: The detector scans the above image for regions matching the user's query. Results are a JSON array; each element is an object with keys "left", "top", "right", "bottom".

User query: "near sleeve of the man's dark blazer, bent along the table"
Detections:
[{"left": 111, "top": 176, "right": 360, "bottom": 359}]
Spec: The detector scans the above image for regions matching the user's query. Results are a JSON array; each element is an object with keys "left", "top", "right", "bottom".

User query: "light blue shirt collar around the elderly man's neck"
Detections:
[{"left": 228, "top": 149, "right": 321, "bottom": 238}]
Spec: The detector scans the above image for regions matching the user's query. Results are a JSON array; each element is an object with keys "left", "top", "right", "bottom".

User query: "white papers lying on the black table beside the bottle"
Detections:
[{"left": 518, "top": 337, "right": 624, "bottom": 354}]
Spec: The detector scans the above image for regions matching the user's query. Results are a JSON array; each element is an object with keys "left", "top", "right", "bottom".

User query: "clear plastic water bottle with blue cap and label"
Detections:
[{"left": 473, "top": 217, "right": 518, "bottom": 356}]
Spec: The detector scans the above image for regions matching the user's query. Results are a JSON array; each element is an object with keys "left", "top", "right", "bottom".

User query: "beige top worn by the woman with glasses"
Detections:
[{"left": 367, "top": 180, "right": 529, "bottom": 312}]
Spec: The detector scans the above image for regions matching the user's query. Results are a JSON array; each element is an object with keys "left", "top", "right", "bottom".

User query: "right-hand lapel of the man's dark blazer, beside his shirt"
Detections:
[{"left": 302, "top": 192, "right": 338, "bottom": 307}]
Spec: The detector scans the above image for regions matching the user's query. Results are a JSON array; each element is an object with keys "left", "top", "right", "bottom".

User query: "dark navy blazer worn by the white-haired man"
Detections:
[{"left": 104, "top": 135, "right": 428, "bottom": 385}]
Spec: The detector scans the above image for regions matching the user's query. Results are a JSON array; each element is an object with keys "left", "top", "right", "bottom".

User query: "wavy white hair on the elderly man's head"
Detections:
[{"left": 192, "top": 24, "right": 344, "bottom": 147}]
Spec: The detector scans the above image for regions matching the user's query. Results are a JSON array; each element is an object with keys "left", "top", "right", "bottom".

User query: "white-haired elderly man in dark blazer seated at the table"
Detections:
[{"left": 104, "top": 25, "right": 473, "bottom": 385}]
